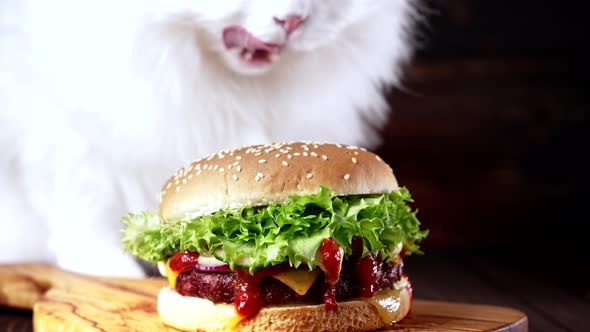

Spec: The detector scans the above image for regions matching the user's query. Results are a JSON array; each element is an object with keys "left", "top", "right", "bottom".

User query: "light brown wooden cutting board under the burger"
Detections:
[{"left": 0, "top": 264, "right": 528, "bottom": 332}]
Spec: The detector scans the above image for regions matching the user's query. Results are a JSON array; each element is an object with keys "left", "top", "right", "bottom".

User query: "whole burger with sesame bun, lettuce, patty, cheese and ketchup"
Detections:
[{"left": 122, "top": 142, "right": 427, "bottom": 331}]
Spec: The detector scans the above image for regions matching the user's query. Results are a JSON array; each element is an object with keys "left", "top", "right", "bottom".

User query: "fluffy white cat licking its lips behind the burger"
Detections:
[{"left": 0, "top": 0, "right": 416, "bottom": 276}]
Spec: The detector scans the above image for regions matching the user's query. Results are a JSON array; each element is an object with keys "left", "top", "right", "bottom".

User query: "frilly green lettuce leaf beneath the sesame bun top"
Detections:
[{"left": 122, "top": 187, "right": 428, "bottom": 272}]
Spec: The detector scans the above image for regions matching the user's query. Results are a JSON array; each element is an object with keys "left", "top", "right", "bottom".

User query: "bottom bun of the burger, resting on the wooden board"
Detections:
[{"left": 158, "top": 287, "right": 411, "bottom": 331}]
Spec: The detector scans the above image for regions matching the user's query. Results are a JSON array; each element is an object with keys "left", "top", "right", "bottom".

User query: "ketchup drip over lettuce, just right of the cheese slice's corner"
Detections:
[{"left": 320, "top": 238, "right": 343, "bottom": 310}]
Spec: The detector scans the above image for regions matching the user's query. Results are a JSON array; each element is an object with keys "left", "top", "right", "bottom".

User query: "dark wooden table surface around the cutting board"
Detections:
[{"left": 0, "top": 252, "right": 590, "bottom": 332}]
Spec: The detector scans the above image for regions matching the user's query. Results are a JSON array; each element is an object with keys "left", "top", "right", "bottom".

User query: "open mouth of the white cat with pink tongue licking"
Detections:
[{"left": 223, "top": 26, "right": 281, "bottom": 66}]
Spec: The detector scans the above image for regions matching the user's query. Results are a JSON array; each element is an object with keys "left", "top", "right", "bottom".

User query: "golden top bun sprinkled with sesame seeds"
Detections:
[{"left": 160, "top": 142, "right": 398, "bottom": 221}]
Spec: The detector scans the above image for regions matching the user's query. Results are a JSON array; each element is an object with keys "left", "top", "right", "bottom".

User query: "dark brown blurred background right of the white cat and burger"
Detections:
[{"left": 378, "top": 0, "right": 590, "bottom": 331}]
